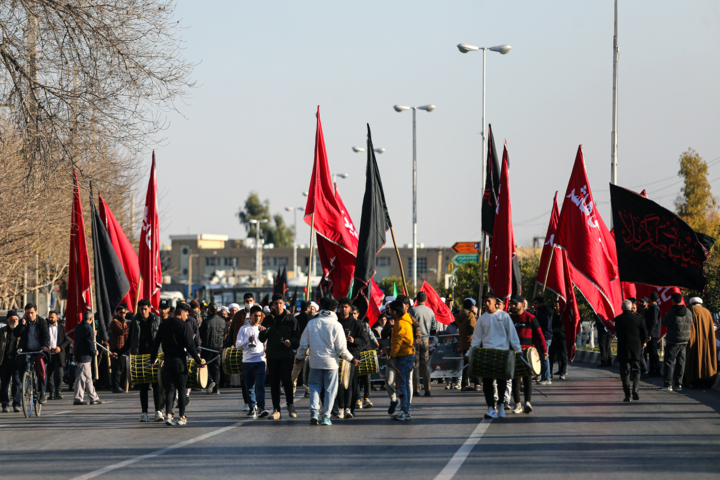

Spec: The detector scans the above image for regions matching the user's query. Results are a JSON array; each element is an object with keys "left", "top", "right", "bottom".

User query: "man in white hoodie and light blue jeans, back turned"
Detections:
[{"left": 295, "top": 299, "right": 360, "bottom": 426}]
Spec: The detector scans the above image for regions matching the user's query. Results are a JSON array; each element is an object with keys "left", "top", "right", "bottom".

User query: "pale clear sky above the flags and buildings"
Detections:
[{"left": 145, "top": 0, "right": 720, "bottom": 251}]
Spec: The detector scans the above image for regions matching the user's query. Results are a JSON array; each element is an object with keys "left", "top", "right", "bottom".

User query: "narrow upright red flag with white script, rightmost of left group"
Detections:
[{"left": 138, "top": 151, "right": 162, "bottom": 313}]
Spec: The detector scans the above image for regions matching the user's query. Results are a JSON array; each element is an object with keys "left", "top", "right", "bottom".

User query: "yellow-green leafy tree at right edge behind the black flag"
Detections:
[{"left": 675, "top": 148, "right": 720, "bottom": 237}]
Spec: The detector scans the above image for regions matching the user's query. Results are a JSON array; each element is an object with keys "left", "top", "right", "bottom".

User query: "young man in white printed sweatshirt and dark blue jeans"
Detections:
[{"left": 235, "top": 306, "right": 270, "bottom": 418}]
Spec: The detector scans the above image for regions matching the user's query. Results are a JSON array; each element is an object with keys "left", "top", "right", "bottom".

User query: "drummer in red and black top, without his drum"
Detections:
[{"left": 508, "top": 295, "right": 548, "bottom": 413}]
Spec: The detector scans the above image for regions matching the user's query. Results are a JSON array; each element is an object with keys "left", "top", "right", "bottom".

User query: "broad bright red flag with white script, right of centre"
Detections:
[{"left": 555, "top": 145, "right": 622, "bottom": 331}]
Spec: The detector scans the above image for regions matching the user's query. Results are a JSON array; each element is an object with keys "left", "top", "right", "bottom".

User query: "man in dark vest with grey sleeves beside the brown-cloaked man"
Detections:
[{"left": 661, "top": 293, "right": 693, "bottom": 392}]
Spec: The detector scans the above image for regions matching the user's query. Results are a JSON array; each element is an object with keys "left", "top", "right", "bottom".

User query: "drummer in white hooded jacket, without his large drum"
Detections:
[{"left": 470, "top": 295, "right": 522, "bottom": 418}]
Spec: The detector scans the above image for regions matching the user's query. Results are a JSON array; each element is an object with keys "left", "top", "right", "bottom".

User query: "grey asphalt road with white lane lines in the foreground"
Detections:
[{"left": 0, "top": 365, "right": 720, "bottom": 480}]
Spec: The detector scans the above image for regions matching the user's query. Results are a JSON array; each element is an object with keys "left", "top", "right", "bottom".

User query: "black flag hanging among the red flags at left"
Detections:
[{"left": 90, "top": 201, "right": 130, "bottom": 342}]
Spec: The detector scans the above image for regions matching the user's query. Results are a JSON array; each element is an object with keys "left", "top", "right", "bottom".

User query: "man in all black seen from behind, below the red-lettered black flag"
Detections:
[{"left": 615, "top": 300, "right": 648, "bottom": 402}]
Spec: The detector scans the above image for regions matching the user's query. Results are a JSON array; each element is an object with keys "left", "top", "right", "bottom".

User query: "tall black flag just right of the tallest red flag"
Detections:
[{"left": 353, "top": 124, "right": 392, "bottom": 318}]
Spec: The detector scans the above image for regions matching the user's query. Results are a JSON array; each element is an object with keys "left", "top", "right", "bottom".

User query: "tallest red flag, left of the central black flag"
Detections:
[{"left": 305, "top": 107, "right": 358, "bottom": 298}]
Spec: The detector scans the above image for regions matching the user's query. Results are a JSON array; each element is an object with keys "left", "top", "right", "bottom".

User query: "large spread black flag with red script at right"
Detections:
[{"left": 610, "top": 184, "right": 715, "bottom": 292}]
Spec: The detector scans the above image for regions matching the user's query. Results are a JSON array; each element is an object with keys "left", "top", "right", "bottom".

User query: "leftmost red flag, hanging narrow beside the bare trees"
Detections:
[{"left": 65, "top": 169, "right": 92, "bottom": 338}]
